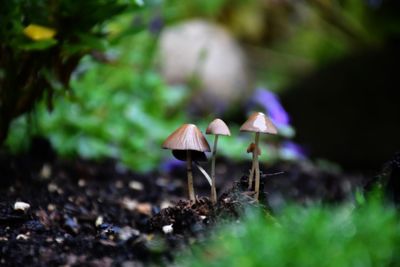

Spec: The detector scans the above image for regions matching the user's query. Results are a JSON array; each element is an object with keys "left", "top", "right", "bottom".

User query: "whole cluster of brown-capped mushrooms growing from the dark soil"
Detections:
[{"left": 162, "top": 112, "right": 278, "bottom": 204}]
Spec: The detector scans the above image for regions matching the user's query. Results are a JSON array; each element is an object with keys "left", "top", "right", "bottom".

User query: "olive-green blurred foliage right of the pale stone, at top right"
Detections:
[{"left": 216, "top": 0, "right": 400, "bottom": 91}]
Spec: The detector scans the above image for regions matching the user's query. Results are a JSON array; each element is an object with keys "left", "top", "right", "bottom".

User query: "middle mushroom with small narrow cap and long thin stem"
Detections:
[{"left": 206, "top": 119, "right": 231, "bottom": 204}]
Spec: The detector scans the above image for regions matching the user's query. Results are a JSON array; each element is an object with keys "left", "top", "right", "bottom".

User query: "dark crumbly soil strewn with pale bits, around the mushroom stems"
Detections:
[{"left": 0, "top": 140, "right": 363, "bottom": 266}]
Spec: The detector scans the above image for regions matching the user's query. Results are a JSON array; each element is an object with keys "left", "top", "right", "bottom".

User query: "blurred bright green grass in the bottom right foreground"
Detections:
[{"left": 177, "top": 196, "right": 400, "bottom": 267}]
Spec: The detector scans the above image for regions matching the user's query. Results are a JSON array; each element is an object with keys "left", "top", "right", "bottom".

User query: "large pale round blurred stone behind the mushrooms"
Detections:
[{"left": 160, "top": 19, "right": 251, "bottom": 113}]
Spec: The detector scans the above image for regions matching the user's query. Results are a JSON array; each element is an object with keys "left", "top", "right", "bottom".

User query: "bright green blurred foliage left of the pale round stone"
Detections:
[{"left": 3, "top": 0, "right": 284, "bottom": 171}]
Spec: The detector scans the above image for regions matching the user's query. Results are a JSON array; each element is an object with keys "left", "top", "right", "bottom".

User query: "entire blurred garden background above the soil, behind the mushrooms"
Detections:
[{"left": 0, "top": 0, "right": 400, "bottom": 176}]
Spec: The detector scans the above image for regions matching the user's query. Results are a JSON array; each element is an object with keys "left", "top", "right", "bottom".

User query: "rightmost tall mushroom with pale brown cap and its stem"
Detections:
[{"left": 240, "top": 112, "right": 278, "bottom": 200}]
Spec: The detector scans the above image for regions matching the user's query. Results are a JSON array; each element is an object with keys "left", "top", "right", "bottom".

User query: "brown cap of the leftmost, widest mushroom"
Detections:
[{"left": 162, "top": 124, "right": 211, "bottom": 152}]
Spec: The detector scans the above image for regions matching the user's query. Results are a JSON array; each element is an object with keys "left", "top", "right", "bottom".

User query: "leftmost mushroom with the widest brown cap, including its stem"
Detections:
[{"left": 162, "top": 124, "right": 210, "bottom": 201}]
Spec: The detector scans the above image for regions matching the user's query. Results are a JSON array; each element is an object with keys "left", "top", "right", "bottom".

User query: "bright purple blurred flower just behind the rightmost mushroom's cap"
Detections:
[{"left": 251, "top": 88, "right": 290, "bottom": 127}]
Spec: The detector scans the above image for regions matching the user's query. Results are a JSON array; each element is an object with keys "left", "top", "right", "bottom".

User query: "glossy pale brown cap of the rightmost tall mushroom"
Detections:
[{"left": 240, "top": 112, "right": 278, "bottom": 134}]
